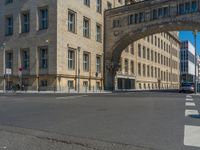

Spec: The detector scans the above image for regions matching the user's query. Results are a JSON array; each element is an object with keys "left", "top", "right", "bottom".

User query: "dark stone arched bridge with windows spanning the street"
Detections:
[{"left": 104, "top": 0, "right": 200, "bottom": 90}]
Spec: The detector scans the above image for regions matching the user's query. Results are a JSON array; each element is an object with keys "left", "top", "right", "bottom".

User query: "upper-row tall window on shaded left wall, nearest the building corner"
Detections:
[{"left": 39, "top": 8, "right": 48, "bottom": 30}]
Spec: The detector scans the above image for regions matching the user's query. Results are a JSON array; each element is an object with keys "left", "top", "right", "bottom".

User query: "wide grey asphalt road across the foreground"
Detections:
[{"left": 0, "top": 92, "right": 200, "bottom": 150}]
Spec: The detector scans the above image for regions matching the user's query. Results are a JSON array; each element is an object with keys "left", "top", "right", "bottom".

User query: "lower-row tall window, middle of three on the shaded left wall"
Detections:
[{"left": 22, "top": 49, "right": 30, "bottom": 70}]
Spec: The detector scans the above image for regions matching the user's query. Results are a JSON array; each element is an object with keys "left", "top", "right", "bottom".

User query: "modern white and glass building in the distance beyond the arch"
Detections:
[{"left": 180, "top": 41, "right": 195, "bottom": 82}]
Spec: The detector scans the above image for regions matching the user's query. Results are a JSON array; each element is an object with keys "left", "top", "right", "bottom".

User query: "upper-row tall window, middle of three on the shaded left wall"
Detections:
[{"left": 21, "top": 12, "right": 30, "bottom": 33}]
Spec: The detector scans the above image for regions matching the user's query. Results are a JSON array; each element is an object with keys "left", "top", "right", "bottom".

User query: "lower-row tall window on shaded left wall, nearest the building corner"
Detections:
[{"left": 39, "top": 47, "right": 48, "bottom": 69}]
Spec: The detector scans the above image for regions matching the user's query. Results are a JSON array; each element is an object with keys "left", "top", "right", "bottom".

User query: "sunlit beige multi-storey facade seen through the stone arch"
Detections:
[{"left": 115, "top": 32, "right": 180, "bottom": 90}]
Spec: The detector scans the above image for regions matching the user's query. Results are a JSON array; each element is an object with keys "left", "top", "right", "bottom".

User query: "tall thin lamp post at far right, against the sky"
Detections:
[{"left": 193, "top": 30, "right": 198, "bottom": 94}]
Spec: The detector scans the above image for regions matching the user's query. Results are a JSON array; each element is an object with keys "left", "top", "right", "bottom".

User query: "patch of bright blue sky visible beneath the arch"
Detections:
[{"left": 179, "top": 31, "right": 200, "bottom": 54}]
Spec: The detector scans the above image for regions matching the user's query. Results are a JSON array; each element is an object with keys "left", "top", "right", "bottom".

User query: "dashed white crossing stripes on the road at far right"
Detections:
[{"left": 184, "top": 95, "right": 200, "bottom": 148}]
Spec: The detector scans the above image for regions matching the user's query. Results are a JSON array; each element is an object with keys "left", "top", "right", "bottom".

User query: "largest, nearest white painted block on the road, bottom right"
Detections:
[{"left": 184, "top": 125, "right": 200, "bottom": 147}]
